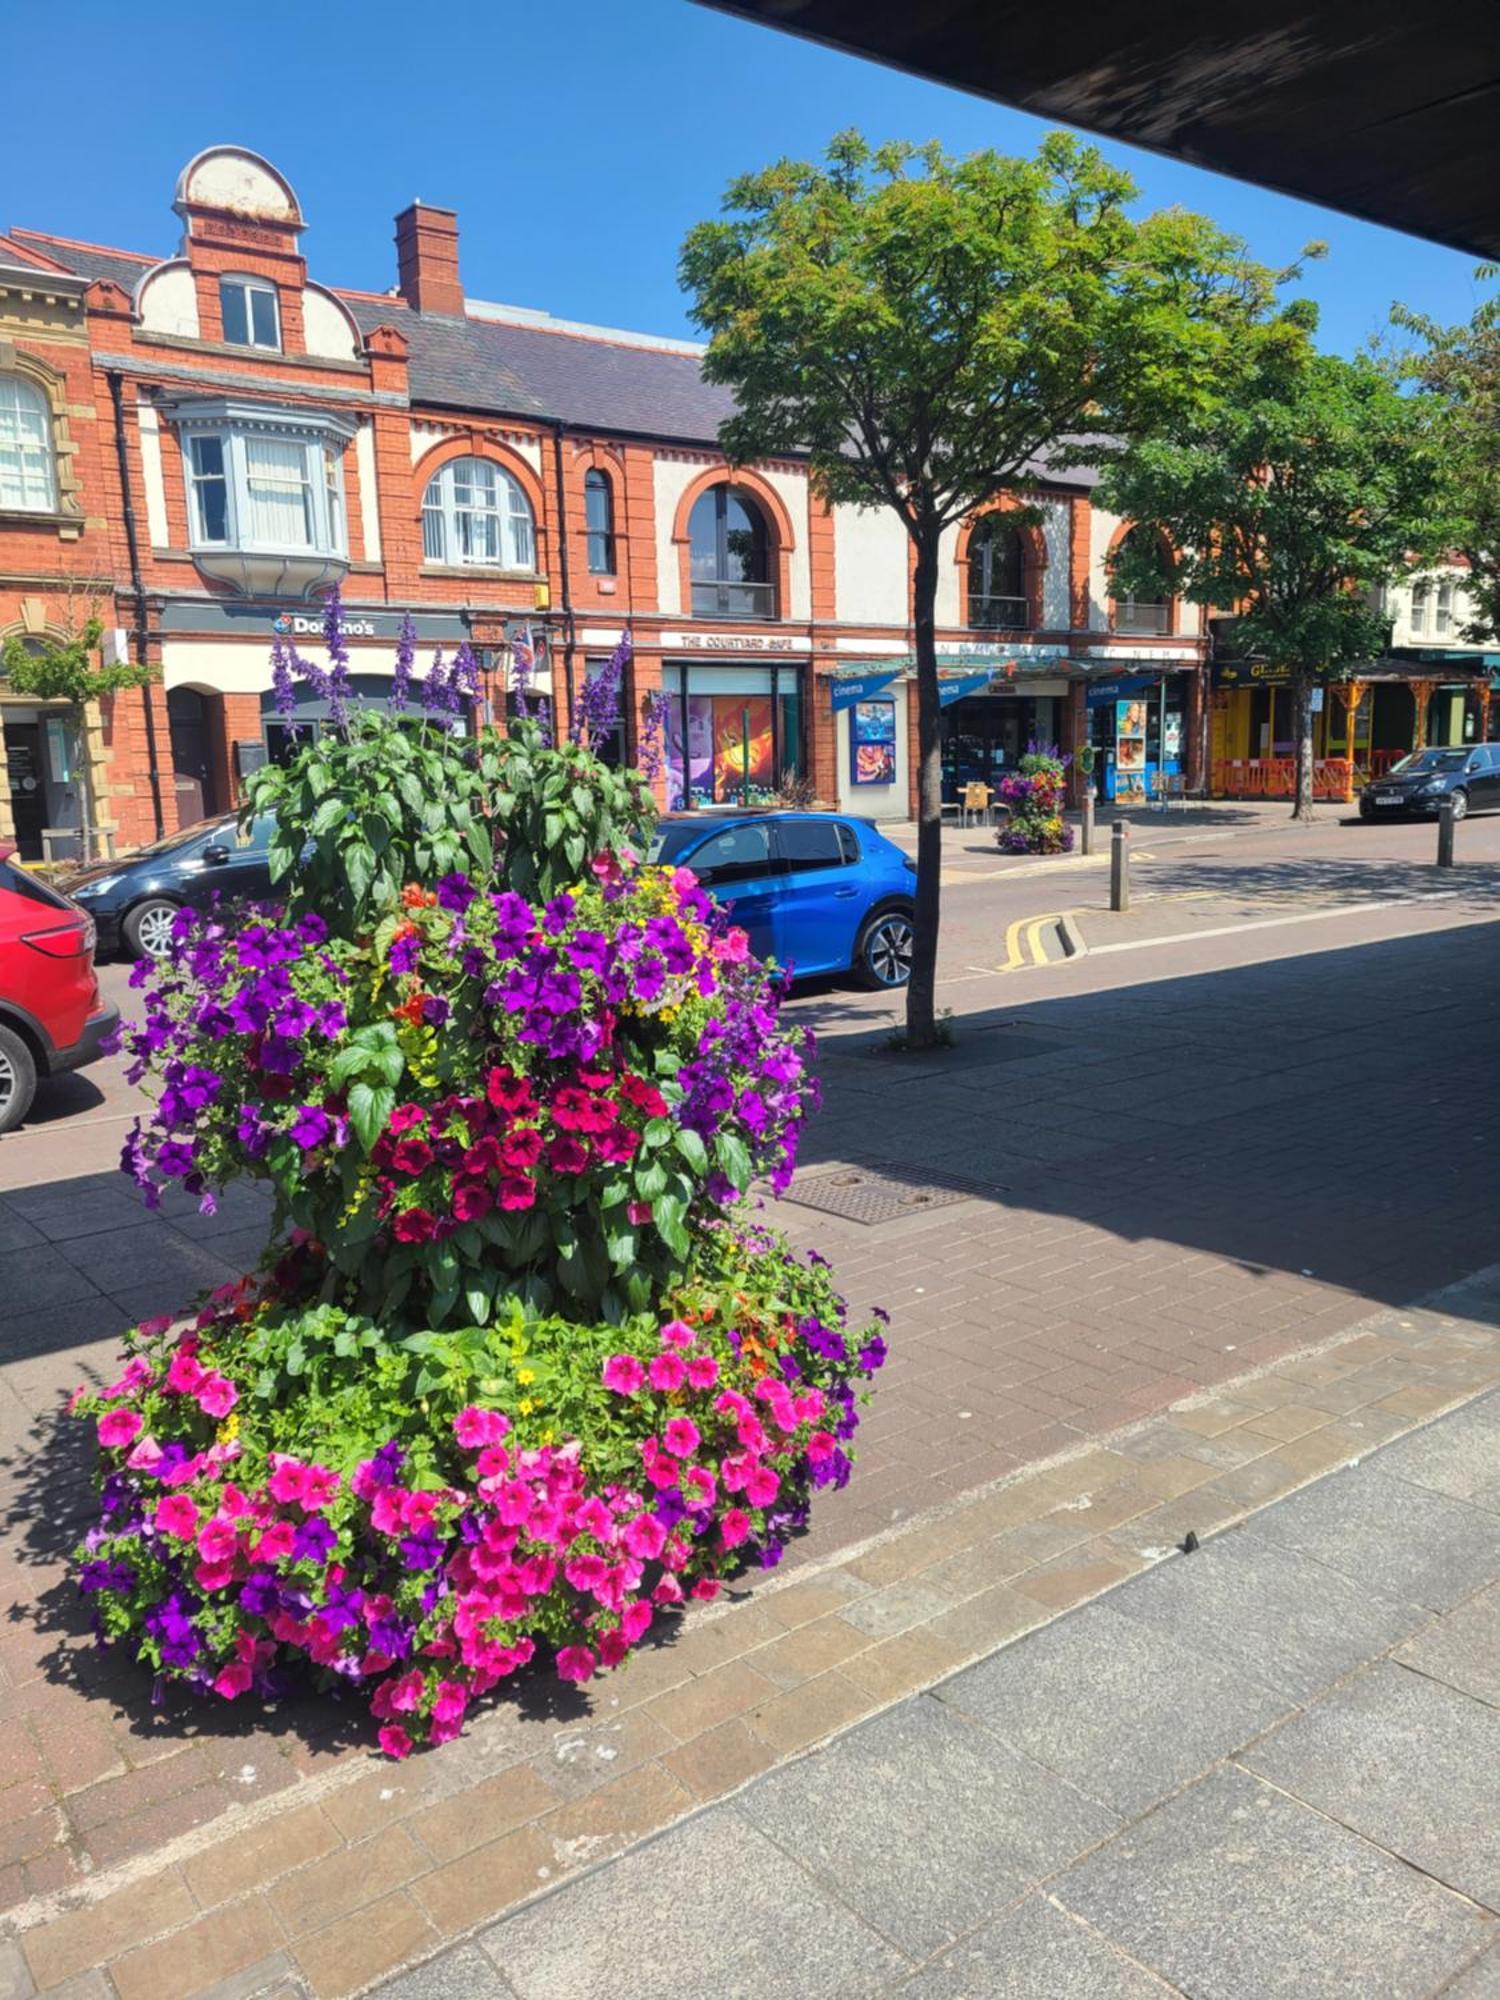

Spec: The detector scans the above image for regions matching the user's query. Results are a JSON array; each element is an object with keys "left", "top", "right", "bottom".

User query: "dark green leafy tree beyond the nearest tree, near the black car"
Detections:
[{"left": 1100, "top": 340, "right": 1438, "bottom": 820}]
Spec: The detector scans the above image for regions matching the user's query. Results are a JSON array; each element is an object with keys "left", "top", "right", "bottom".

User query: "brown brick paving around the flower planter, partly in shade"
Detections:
[{"left": 0, "top": 868, "right": 1500, "bottom": 2000}]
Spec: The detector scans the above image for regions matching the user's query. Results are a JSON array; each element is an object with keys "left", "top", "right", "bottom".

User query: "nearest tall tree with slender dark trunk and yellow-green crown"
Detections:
[{"left": 682, "top": 132, "right": 1276, "bottom": 1048}]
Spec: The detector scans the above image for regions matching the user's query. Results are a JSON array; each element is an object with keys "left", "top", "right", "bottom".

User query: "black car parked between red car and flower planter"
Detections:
[{"left": 64, "top": 816, "right": 272, "bottom": 958}]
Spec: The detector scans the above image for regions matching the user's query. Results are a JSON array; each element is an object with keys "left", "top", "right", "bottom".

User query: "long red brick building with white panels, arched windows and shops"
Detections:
[{"left": 0, "top": 146, "right": 1206, "bottom": 852}]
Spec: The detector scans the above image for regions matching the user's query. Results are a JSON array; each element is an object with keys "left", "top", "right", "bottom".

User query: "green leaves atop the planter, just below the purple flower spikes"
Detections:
[{"left": 244, "top": 710, "right": 654, "bottom": 938}]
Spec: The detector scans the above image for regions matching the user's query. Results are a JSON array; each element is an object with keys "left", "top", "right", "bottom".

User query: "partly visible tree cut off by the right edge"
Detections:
[{"left": 1392, "top": 264, "right": 1500, "bottom": 644}]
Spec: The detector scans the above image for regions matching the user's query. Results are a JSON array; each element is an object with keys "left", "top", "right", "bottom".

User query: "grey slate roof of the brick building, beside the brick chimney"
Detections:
[{"left": 10, "top": 230, "right": 1094, "bottom": 486}]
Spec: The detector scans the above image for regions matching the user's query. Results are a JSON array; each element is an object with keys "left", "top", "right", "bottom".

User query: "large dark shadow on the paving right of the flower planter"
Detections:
[{"left": 792, "top": 920, "right": 1500, "bottom": 1316}]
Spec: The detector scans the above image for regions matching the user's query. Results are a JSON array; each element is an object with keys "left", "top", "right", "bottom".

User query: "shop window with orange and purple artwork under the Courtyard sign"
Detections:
[{"left": 662, "top": 660, "right": 808, "bottom": 812}]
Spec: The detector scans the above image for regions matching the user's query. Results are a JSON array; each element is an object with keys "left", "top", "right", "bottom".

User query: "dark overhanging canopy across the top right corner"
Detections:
[{"left": 704, "top": 0, "right": 1500, "bottom": 258}]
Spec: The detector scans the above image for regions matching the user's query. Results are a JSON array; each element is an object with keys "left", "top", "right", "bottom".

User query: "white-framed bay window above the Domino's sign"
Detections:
[{"left": 166, "top": 402, "right": 356, "bottom": 562}]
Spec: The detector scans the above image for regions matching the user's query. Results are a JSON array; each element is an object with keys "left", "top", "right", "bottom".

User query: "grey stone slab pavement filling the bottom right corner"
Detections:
[{"left": 380, "top": 1394, "right": 1500, "bottom": 2000}]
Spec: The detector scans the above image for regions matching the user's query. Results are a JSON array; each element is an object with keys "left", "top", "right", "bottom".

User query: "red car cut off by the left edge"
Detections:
[{"left": 0, "top": 846, "right": 120, "bottom": 1132}]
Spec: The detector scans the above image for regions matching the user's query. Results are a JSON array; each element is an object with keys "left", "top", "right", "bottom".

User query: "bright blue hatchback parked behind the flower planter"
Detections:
[{"left": 650, "top": 810, "right": 916, "bottom": 986}]
